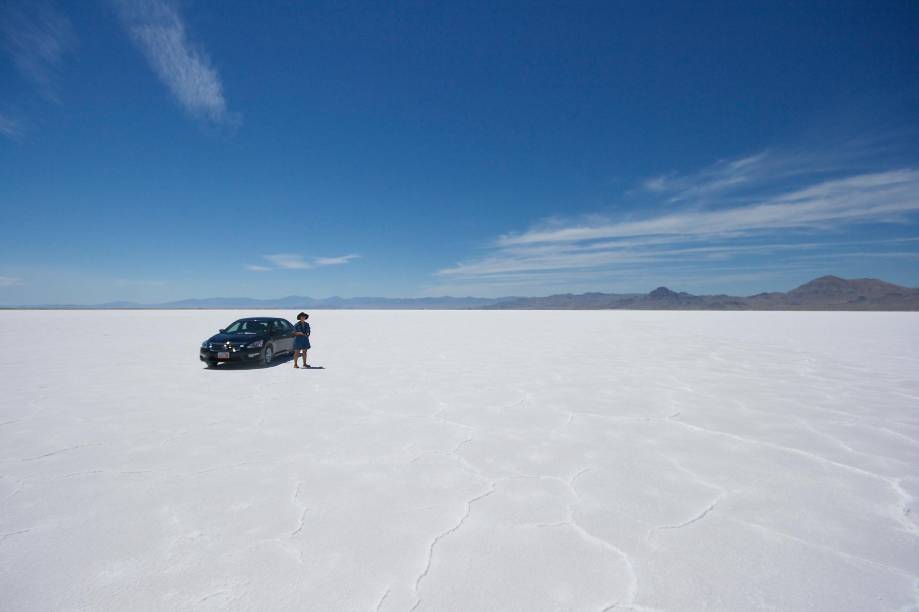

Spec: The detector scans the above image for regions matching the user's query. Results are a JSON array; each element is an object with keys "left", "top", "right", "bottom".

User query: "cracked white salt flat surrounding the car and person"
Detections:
[{"left": 0, "top": 311, "right": 919, "bottom": 612}]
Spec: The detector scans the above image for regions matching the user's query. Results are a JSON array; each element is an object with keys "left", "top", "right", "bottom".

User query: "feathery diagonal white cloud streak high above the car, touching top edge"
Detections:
[{"left": 114, "top": 0, "right": 237, "bottom": 124}]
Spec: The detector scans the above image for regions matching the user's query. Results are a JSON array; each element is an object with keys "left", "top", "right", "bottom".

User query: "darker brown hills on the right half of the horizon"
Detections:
[{"left": 483, "top": 276, "right": 919, "bottom": 310}]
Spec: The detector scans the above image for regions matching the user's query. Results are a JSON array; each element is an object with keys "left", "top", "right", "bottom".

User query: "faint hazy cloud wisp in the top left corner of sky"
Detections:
[{"left": 0, "top": 0, "right": 76, "bottom": 102}]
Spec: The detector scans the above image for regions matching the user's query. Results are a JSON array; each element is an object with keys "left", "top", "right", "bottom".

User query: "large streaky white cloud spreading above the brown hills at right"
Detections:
[{"left": 436, "top": 153, "right": 919, "bottom": 286}]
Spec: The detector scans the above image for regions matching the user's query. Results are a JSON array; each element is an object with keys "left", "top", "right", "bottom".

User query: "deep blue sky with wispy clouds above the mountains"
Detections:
[{"left": 0, "top": 0, "right": 919, "bottom": 305}]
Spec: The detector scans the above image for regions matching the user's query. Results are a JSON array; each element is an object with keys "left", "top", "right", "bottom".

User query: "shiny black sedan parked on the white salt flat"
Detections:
[{"left": 200, "top": 317, "right": 294, "bottom": 368}]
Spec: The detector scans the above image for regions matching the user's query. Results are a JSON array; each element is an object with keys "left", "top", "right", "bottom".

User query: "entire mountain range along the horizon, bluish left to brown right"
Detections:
[{"left": 7, "top": 276, "right": 919, "bottom": 311}]
